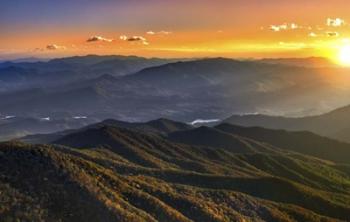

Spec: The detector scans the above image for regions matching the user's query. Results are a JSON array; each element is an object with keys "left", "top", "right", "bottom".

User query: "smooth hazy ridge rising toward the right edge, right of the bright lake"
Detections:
[{"left": 225, "top": 103, "right": 350, "bottom": 142}]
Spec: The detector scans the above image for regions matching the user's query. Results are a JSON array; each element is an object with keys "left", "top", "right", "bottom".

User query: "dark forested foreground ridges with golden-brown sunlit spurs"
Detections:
[{"left": 0, "top": 119, "right": 350, "bottom": 222}]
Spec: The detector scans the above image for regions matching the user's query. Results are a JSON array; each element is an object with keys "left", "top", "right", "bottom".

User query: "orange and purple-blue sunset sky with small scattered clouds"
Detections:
[{"left": 0, "top": 0, "right": 350, "bottom": 59}]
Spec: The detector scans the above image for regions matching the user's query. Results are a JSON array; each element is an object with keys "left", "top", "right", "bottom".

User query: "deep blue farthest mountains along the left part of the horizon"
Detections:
[{"left": 0, "top": 55, "right": 173, "bottom": 87}]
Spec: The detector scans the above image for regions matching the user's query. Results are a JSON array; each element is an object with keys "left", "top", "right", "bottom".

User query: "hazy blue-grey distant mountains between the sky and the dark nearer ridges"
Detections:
[{"left": 0, "top": 55, "right": 350, "bottom": 122}]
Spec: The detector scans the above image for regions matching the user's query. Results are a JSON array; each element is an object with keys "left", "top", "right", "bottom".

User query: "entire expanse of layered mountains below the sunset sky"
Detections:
[{"left": 0, "top": 55, "right": 350, "bottom": 222}]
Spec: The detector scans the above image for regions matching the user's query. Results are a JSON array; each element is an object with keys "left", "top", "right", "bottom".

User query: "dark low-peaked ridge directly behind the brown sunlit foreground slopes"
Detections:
[{"left": 25, "top": 119, "right": 350, "bottom": 163}]
